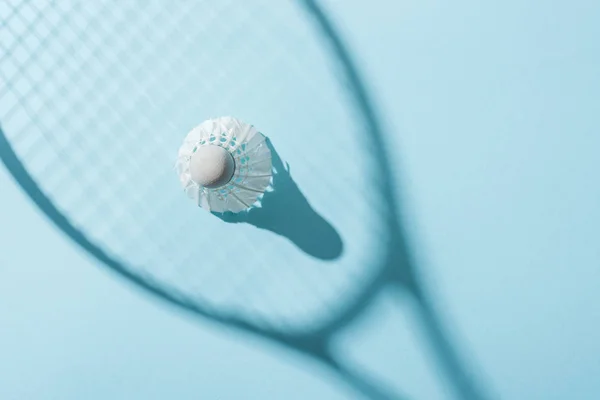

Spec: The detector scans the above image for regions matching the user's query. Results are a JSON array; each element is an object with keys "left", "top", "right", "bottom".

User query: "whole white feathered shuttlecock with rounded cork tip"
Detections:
[{"left": 176, "top": 117, "right": 272, "bottom": 213}]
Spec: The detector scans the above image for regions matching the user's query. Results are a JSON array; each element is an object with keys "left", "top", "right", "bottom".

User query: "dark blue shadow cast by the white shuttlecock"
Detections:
[{"left": 213, "top": 139, "right": 344, "bottom": 260}]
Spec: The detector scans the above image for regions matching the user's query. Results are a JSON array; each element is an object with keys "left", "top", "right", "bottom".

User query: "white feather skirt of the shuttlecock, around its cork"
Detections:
[{"left": 176, "top": 117, "right": 272, "bottom": 213}]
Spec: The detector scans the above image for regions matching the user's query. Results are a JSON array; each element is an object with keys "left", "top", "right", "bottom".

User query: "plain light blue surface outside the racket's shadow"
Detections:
[{"left": 0, "top": 0, "right": 600, "bottom": 400}]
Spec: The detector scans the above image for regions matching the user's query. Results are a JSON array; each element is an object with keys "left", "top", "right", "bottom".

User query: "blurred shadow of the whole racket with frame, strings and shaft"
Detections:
[{"left": 0, "top": 0, "right": 492, "bottom": 399}]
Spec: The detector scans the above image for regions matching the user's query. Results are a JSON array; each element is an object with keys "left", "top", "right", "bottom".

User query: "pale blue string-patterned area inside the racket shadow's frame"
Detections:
[{"left": 0, "top": 0, "right": 384, "bottom": 330}]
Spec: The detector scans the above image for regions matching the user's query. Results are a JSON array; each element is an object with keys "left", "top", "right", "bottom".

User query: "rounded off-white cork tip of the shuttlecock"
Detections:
[{"left": 190, "top": 145, "right": 235, "bottom": 189}]
